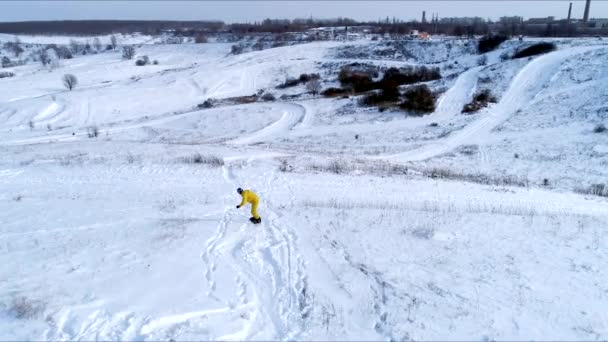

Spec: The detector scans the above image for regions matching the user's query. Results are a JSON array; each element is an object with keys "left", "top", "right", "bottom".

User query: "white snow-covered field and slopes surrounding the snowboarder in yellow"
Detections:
[{"left": 0, "top": 35, "right": 608, "bottom": 341}]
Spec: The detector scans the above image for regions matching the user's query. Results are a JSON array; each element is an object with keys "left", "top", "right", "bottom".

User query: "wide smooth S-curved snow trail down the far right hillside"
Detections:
[{"left": 384, "top": 46, "right": 603, "bottom": 161}]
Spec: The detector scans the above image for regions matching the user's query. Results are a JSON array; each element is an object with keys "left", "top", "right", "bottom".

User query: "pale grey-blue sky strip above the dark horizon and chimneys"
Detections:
[{"left": 0, "top": 0, "right": 608, "bottom": 22}]
